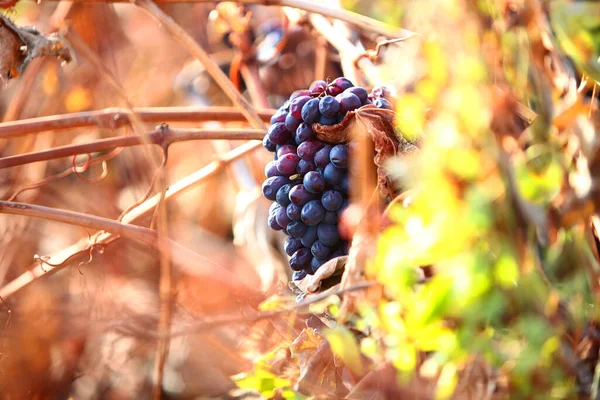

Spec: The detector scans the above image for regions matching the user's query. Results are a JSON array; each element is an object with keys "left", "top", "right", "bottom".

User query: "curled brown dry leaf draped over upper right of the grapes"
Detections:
[{"left": 313, "top": 105, "right": 417, "bottom": 199}]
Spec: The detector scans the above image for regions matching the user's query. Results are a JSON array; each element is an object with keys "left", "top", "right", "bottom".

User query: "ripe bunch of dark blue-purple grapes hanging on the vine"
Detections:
[{"left": 262, "top": 78, "right": 393, "bottom": 280}]
